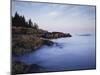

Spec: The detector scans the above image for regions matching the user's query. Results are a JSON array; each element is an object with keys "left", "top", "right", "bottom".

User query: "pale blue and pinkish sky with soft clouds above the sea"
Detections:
[{"left": 12, "top": 1, "right": 95, "bottom": 33}]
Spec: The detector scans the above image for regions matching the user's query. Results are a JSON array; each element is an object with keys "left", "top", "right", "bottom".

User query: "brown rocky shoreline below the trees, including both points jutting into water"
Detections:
[{"left": 12, "top": 27, "right": 71, "bottom": 55}]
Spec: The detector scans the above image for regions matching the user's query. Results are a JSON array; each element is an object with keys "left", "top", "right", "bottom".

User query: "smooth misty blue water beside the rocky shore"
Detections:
[{"left": 13, "top": 35, "right": 96, "bottom": 71}]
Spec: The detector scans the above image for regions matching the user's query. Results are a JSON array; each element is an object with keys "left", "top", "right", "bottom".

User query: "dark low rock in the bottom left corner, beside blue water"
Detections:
[{"left": 11, "top": 61, "right": 41, "bottom": 75}]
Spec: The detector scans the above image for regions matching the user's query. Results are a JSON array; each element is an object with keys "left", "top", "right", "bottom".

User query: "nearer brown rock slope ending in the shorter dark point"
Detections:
[{"left": 12, "top": 35, "right": 53, "bottom": 56}]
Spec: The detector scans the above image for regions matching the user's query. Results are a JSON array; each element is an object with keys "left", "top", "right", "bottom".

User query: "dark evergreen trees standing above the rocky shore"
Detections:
[{"left": 12, "top": 12, "right": 38, "bottom": 29}]
